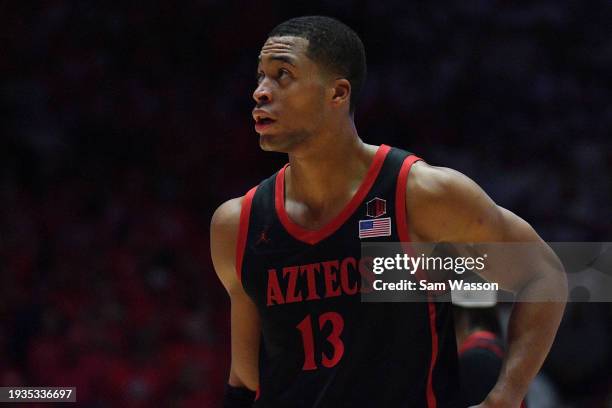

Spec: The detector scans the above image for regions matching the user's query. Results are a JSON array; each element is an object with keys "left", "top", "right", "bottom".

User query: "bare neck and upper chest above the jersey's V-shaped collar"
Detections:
[{"left": 285, "top": 122, "right": 376, "bottom": 227}]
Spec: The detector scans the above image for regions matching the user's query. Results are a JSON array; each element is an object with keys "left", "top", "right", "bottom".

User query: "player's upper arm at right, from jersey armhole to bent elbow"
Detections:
[{"left": 412, "top": 166, "right": 554, "bottom": 291}]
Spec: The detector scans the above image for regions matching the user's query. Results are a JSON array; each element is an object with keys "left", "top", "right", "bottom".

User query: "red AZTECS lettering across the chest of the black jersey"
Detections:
[{"left": 266, "top": 257, "right": 374, "bottom": 306}]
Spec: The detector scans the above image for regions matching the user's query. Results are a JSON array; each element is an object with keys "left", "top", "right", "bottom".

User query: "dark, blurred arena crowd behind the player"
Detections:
[{"left": 0, "top": 0, "right": 612, "bottom": 407}]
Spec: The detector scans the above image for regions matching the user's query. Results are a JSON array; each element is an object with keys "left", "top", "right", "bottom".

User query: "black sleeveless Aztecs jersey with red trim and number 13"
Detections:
[{"left": 237, "top": 145, "right": 459, "bottom": 408}]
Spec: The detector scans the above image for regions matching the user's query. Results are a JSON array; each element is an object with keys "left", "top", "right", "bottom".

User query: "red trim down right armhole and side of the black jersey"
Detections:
[{"left": 395, "top": 155, "right": 438, "bottom": 408}]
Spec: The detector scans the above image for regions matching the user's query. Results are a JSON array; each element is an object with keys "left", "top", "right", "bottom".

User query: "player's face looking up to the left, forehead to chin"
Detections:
[{"left": 253, "top": 36, "right": 326, "bottom": 153}]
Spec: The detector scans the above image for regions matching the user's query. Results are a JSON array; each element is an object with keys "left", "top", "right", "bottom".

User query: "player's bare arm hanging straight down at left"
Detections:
[{"left": 210, "top": 198, "right": 261, "bottom": 391}]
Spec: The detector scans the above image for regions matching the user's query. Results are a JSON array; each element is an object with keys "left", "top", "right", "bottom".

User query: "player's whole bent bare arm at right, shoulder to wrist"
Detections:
[{"left": 406, "top": 162, "right": 567, "bottom": 408}]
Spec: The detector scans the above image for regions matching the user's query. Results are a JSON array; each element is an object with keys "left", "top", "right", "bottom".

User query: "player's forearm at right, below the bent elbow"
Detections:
[{"left": 486, "top": 272, "right": 567, "bottom": 407}]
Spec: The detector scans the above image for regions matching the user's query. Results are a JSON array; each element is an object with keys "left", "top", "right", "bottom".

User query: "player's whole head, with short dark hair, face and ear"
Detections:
[{"left": 253, "top": 16, "right": 366, "bottom": 152}]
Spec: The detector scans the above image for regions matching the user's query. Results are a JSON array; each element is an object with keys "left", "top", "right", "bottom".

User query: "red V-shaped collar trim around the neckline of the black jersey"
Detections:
[{"left": 274, "top": 145, "right": 391, "bottom": 245}]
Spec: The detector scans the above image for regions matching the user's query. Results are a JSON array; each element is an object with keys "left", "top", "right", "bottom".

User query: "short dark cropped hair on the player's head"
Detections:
[{"left": 268, "top": 16, "right": 366, "bottom": 113}]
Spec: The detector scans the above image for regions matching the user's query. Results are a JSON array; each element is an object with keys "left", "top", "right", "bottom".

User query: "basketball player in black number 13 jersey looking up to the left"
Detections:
[{"left": 211, "top": 17, "right": 566, "bottom": 408}]
